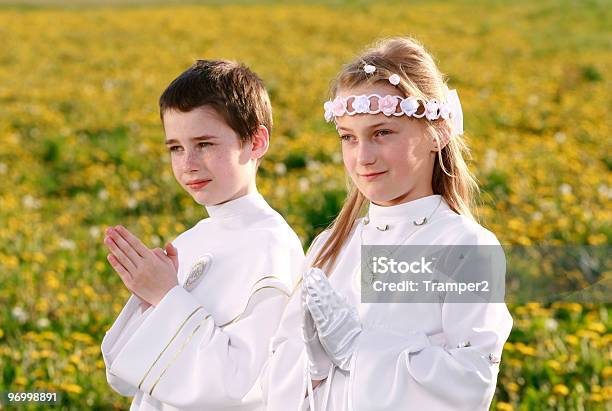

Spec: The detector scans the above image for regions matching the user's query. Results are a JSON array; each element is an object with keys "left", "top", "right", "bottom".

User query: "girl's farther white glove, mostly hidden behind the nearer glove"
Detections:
[{"left": 301, "top": 272, "right": 332, "bottom": 380}]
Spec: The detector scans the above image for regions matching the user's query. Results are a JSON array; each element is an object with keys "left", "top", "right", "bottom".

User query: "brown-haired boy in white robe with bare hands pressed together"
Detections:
[{"left": 102, "top": 60, "right": 304, "bottom": 410}]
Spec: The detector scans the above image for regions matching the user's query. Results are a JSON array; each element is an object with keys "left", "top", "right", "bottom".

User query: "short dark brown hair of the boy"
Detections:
[{"left": 159, "top": 60, "right": 272, "bottom": 144}]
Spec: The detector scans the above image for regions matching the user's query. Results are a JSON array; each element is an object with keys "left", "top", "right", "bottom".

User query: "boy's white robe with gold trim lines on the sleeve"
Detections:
[{"left": 102, "top": 193, "right": 304, "bottom": 411}]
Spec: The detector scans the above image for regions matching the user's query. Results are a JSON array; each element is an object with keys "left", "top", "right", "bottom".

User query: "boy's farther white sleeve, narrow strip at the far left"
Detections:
[{"left": 101, "top": 295, "right": 152, "bottom": 397}]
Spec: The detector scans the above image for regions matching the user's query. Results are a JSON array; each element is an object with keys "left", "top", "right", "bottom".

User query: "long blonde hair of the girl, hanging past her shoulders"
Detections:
[{"left": 313, "top": 37, "right": 478, "bottom": 273}]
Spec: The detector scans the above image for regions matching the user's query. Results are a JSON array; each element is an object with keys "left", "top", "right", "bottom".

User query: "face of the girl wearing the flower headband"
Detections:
[{"left": 336, "top": 84, "right": 436, "bottom": 206}]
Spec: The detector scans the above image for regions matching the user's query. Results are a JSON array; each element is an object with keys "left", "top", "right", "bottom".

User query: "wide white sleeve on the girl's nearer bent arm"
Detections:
[{"left": 349, "top": 240, "right": 512, "bottom": 411}]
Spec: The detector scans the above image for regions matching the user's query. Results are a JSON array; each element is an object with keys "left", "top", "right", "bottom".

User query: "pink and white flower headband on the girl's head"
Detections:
[{"left": 323, "top": 64, "right": 463, "bottom": 134}]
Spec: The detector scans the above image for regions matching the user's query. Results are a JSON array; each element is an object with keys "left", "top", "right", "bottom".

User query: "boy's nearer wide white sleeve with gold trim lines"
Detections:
[{"left": 109, "top": 246, "right": 303, "bottom": 409}]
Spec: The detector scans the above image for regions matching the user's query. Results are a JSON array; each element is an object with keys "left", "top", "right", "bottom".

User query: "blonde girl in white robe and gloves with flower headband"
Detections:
[{"left": 262, "top": 38, "right": 512, "bottom": 411}]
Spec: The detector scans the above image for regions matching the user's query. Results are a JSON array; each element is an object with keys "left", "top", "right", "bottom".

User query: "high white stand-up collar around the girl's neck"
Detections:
[{"left": 368, "top": 194, "right": 448, "bottom": 222}]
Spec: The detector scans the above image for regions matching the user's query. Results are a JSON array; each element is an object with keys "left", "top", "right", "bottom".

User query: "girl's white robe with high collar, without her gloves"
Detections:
[{"left": 262, "top": 195, "right": 512, "bottom": 411}]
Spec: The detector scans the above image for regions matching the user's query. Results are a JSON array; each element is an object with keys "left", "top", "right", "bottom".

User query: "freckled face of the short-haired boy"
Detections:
[{"left": 164, "top": 106, "right": 256, "bottom": 206}]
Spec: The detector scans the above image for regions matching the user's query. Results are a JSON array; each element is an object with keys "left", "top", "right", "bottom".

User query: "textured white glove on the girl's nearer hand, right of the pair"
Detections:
[{"left": 303, "top": 268, "right": 361, "bottom": 371}]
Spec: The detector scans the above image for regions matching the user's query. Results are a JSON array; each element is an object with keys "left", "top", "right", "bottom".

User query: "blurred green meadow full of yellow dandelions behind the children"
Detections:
[{"left": 0, "top": 0, "right": 612, "bottom": 410}]
